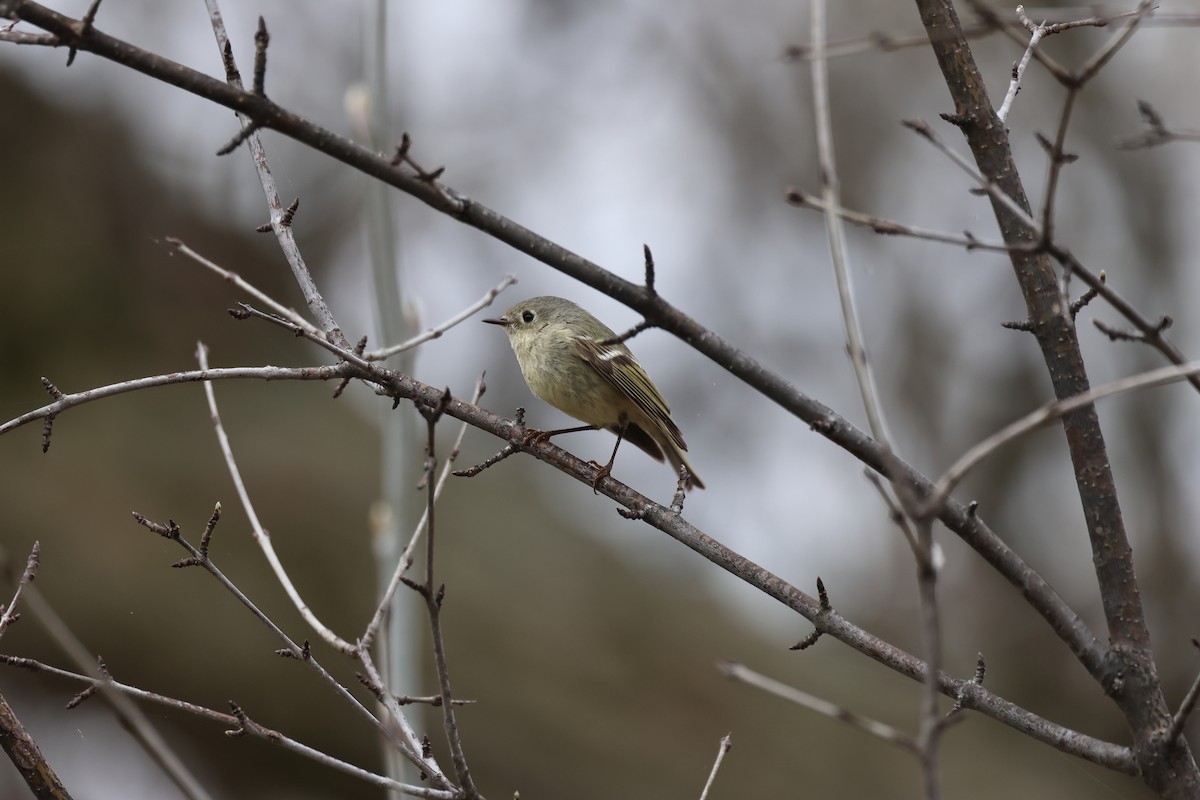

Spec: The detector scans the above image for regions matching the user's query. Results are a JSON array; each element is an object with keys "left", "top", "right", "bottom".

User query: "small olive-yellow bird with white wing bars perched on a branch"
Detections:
[{"left": 484, "top": 296, "right": 704, "bottom": 489}]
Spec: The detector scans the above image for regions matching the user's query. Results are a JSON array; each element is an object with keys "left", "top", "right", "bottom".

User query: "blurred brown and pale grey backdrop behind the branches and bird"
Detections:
[{"left": 0, "top": 0, "right": 1200, "bottom": 799}]
